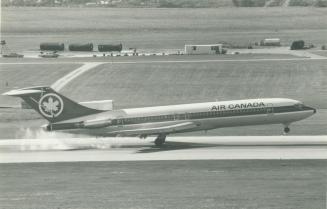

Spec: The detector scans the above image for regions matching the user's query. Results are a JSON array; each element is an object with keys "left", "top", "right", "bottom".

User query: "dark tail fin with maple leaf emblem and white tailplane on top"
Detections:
[{"left": 3, "top": 86, "right": 103, "bottom": 123}]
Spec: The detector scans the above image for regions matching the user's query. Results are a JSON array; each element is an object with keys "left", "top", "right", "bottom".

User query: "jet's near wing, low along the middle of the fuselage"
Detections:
[{"left": 109, "top": 122, "right": 198, "bottom": 136}]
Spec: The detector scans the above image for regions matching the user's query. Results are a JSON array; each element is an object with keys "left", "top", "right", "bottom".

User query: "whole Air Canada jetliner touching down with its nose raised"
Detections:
[{"left": 3, "top": 87, "right": 316, "bottom": 146}]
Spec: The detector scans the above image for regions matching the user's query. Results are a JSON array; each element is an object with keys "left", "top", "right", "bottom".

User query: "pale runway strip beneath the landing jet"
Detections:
[{"left": 0, "top": 136, "right": 327, "bottom": 163}]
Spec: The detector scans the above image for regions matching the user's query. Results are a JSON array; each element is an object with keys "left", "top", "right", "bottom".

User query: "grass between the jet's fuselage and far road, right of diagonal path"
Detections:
[{"left": 63, "top": 60, "right": 327, "bottom": 109}]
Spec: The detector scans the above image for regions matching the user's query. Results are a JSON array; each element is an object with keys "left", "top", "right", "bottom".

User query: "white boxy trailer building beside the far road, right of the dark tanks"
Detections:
[{"left": 185, "top": 44, "right": 226, "bottom": 54}]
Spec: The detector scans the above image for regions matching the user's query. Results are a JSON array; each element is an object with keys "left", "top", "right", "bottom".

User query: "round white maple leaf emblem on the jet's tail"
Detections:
[{"left": 39, "top": 93, "right": 64, "bottom": 118}]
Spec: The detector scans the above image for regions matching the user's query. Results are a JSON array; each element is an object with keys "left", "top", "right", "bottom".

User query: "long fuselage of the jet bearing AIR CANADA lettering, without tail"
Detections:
[{"left": 60, "top": 98, "right": 316, "bottom": 135}]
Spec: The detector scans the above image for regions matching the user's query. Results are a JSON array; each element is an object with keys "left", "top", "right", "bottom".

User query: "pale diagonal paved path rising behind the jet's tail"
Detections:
[{"left": 51, "top": 62, "right": 103, "bottom": 91}]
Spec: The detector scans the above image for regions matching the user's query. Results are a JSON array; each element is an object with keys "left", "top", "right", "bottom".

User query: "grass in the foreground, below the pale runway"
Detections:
[{"left": 0, "top": 160, "right": 327, "bottom": 209}]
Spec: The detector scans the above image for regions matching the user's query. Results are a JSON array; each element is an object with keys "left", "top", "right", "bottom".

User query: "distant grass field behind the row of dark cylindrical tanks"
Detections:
[{"left": 1, "top": 7, "right": 327, "bottom": 51}]
